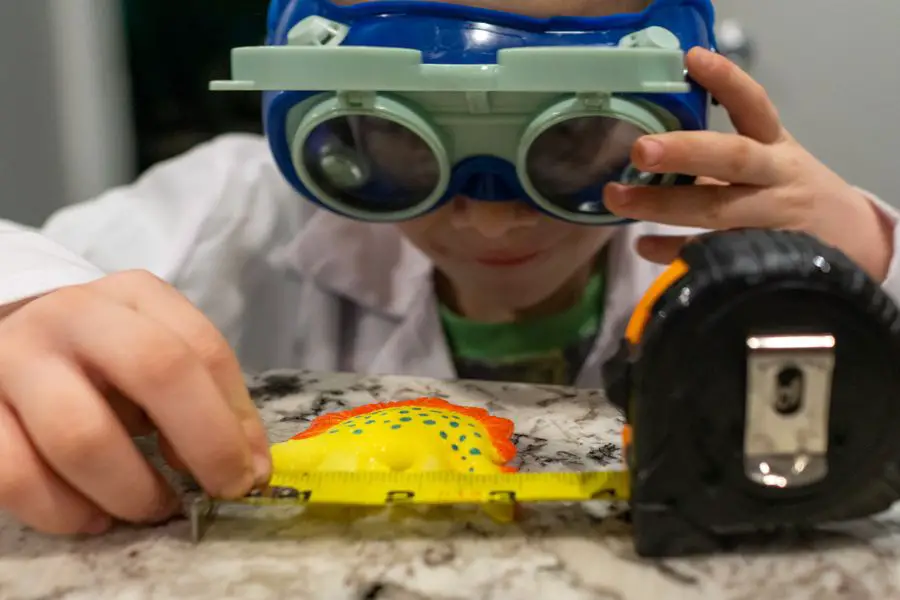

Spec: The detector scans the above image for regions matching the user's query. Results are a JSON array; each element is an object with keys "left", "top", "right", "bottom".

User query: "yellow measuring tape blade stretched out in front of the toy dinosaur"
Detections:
[{"left": 239, "top": 471, "right": 630, "bottom": 506}]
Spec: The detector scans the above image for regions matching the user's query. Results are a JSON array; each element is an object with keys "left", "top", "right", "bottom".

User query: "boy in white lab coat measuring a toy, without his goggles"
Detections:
[{"left": 0, "top": 0, "right": 900, "bottom": 533}]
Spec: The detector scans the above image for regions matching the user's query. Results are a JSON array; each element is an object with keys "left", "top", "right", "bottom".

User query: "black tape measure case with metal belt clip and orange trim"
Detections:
[{"left": 604, "top": 230, "right": 900, "bottom": 556}]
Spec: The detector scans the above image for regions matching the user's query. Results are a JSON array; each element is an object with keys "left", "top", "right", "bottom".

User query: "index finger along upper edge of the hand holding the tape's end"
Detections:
[{"left": 97, "top": 272, "right": 271, "bottom": 483}]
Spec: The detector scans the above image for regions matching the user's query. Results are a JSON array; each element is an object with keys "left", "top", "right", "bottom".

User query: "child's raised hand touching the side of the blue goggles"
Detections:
[{"left": 605, "top": 48, "right": 893, "bottom": 282}]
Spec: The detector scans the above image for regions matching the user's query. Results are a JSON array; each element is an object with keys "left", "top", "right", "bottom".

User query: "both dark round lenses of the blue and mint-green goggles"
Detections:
[{"left": 298, "top": 106, "right": 664, "bottom": 223}]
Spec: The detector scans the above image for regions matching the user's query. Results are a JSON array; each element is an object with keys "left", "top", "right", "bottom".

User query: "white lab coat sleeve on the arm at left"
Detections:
[{"left": 0, "top": 134, "right": 298, "bottom": 338}]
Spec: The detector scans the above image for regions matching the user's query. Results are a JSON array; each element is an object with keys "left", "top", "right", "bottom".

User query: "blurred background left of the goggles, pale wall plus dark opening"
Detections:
[{"left": 0, "top": 0, "right": 268, "bottom": 225}]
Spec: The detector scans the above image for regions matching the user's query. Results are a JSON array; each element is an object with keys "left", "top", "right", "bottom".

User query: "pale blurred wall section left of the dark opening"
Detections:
[{"left": 0, "top": 0, "right": 133, "bottom": 225}]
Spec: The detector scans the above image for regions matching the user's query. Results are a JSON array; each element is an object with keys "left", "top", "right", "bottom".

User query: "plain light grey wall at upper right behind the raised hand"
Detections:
[{"left": 714, "top": 0, "right": 900, "bottom": 207}]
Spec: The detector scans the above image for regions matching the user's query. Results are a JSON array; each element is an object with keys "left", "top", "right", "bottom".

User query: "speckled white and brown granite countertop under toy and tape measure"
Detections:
[{"left": 0, "top": 372, "right": 900, "bottom": 600}]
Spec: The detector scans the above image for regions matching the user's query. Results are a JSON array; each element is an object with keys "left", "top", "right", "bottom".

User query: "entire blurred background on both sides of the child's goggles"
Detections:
[{"left": 0, "top": 0, "right": 900, "bottom": 225}]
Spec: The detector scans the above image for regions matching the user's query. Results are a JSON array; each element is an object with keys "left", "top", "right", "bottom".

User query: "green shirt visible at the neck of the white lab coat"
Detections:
[{"left": 440, "top": 273, "right": 604, "bottom": 385}]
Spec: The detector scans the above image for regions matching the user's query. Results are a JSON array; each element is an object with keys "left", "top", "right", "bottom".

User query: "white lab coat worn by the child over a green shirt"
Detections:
[{"left": 0, "top": 135, "right": 900, "bottom": 388}]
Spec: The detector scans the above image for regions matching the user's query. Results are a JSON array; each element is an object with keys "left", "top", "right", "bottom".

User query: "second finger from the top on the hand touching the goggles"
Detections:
[{"left": 631, "top": 131, "right": 786, "bottom": 186}]
